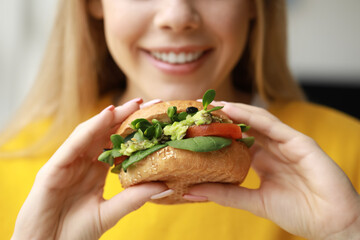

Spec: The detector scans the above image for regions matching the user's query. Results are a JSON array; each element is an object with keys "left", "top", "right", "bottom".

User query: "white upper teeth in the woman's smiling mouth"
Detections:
[{"left": 151, "top": 51, "right": 204, "bottom": 64}]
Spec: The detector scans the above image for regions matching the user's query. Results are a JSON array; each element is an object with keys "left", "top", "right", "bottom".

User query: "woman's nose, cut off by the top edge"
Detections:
[{"left": 154, "top": 0, "right": 201, "bottom": 33}]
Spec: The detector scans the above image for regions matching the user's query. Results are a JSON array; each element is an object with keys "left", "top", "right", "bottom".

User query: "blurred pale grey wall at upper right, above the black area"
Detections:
[{"left": 286, "top": 0, "right": 360, "bottom": 83}]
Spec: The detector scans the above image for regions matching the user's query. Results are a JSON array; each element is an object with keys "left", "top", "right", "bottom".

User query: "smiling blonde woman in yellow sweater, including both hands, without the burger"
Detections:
[{"left": 0, "top": 0, "right": 360, "bottom": 239}]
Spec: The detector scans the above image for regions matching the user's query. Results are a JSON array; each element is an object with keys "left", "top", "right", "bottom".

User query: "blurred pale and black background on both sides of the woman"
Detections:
[{"left": 0, "top": 0, "right": 360, "bottom": 128}]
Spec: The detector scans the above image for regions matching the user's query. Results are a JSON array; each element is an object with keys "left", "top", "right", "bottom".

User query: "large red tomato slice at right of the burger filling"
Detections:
[{"left": 185, "top": 123, "right": 242, "bottom": 139}]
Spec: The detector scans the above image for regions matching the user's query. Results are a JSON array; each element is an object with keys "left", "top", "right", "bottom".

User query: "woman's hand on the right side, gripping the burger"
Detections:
[{"left": 185, "top": 101, "right": 360, "bottom": 239}]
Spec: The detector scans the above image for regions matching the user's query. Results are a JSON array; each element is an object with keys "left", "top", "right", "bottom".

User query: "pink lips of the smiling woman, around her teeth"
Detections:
[{"left": 140, "top": 46, "right": 213, "bottom": 75}]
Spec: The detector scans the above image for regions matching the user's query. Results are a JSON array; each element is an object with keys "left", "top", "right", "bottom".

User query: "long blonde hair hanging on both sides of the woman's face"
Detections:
[{"left": 0, "top": 0, "right": 303, "bottom": 156}]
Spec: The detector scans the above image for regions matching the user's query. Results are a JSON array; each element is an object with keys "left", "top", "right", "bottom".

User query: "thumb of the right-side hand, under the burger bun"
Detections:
[{"left": 184, "top": 183, "right": 265, "bottom": 217}]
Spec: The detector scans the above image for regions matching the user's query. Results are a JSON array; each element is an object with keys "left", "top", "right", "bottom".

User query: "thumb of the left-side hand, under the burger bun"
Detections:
[{"left": 100, "top": 183, "right": 167, "bottom": 232}]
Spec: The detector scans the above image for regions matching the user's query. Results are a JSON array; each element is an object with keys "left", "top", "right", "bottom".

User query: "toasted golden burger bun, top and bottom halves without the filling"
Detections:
[{"left": 118, "top": 101, "right": 251, "bottom": 204}]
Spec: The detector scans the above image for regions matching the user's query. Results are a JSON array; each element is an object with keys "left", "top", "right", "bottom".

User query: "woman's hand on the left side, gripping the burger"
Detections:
[{"left": 13, "top": 99, "right": 167, "bottom": 239}]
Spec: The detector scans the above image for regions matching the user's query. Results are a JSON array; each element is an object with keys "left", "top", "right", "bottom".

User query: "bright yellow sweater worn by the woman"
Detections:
[{"left": 0, "top": 102, "right": 360, "bottom": 240}]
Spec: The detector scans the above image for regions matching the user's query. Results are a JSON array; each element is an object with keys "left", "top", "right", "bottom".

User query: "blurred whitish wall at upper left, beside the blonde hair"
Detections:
[{"left": 0, "top": 0, "right": 57, "bottom": 129}]
